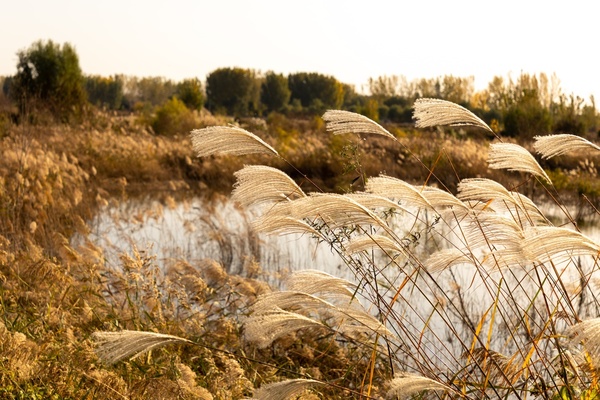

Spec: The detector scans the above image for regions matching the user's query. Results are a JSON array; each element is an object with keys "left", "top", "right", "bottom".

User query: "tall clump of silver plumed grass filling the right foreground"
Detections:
[{"left": 94, "top": 99, "right": 600, "bottom": 399}]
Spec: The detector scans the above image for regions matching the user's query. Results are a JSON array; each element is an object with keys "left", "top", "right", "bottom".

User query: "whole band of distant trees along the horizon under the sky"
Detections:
[{"left": 0, "top": 41, "right": 600, "bottom": 140}]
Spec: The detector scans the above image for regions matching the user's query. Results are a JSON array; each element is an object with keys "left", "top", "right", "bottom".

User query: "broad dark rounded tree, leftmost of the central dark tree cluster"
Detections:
[{"left": 206, "top": 68, "right": 260, "bottom": 117}]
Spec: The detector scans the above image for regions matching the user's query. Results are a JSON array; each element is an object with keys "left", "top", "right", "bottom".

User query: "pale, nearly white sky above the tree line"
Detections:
[{"left": 0, "top": 0, "right": 600, "bottom": 99}]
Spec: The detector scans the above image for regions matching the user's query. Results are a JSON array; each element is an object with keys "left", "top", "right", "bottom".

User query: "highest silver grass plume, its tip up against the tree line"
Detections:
[{"left": 413, "top": 99, "right": 494, "bottom": 133}]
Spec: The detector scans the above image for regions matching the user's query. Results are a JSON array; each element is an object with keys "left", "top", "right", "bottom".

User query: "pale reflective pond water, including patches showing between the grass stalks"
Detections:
[{"left": 78, "top": 197, "right": 600, "bottom": 372}]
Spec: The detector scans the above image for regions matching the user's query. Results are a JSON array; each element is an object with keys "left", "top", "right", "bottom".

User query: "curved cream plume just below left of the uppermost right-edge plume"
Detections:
[{"left": 488, "top": 143, "right": 552, "bottom": 183}]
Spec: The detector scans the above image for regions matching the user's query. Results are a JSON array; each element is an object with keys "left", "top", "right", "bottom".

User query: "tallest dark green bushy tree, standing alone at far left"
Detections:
[{"left": 11, "top": 40, "right": 87, "bottom": 119}]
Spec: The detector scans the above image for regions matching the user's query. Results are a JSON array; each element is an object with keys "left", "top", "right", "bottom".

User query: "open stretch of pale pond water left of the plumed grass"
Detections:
[{"left": 81, "top": 197, "right": 349, "bottom": 281}]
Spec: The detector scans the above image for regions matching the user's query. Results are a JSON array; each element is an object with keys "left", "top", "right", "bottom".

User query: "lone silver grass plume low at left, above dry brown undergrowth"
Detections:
[{"left": 92, "top": 330, "right": 192, "bottom": 364}]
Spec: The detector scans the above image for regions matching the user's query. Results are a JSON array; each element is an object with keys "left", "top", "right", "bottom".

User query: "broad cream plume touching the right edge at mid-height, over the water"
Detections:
[{"left": 522, "top": 226, "right": 600, "bottom": 262}]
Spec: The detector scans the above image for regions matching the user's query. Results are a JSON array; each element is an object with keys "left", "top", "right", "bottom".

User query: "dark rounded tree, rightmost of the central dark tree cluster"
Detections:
[{"left": 288, "top": 72, "right": 344, "bottom": 113}]
